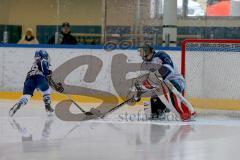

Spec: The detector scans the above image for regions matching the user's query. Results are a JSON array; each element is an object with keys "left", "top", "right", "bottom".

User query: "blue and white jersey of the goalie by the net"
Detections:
[{"left": 145, "top": 51, "right": 184, "bottom": 81}]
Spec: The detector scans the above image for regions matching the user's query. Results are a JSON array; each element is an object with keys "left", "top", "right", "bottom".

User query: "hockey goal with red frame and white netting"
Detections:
[{"left": 181, "top": 39, "right": 240, "bottom": 110}]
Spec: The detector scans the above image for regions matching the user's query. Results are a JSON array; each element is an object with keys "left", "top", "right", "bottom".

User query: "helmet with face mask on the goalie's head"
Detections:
[{"left": 138, "top": 44, "right": 153, "bottom": 61}]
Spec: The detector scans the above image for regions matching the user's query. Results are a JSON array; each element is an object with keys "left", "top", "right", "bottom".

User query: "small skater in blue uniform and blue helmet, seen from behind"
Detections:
[{"left": 9, "top": 50, "right": 63, "bottom": 117}]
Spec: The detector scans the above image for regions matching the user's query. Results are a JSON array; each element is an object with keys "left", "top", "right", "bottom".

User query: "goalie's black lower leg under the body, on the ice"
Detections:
[{"left": 150, "top": 96, "right": 166, "bottom": 115}]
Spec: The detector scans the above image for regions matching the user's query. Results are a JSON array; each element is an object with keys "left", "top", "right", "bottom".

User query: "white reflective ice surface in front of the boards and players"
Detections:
[{"left": 0, "top": 100, "right": 240, "bottom": 160}]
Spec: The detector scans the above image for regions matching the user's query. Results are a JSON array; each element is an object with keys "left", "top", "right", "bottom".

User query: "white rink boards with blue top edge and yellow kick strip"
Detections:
[{"left": 0, "top": 45, "right": 240, "bottom": 110}]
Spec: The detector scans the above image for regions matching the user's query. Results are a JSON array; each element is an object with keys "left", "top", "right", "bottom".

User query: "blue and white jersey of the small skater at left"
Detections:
[{"left": 27, "top": 59, "right": 50, "bottom": 78}]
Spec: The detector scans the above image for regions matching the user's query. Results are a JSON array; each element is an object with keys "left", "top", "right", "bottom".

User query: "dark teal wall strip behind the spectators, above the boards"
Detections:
[{"left": 0, "top": 25, "right": 240, "bottom": 46}]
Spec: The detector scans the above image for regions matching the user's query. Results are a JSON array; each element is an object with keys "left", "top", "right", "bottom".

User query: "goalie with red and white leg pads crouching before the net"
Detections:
[{"left": 139, "top": 44, "right": 196, "bottom": 121}]
